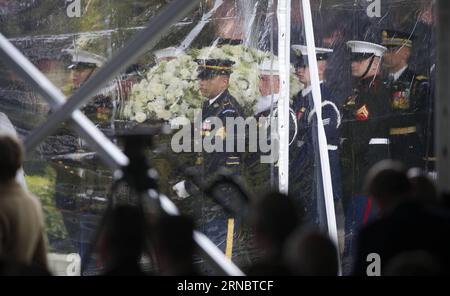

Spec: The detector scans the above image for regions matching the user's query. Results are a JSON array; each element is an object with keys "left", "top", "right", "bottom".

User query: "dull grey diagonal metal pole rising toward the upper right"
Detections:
[{"left": 25, "top": 0, "right": 200, "bottom": 150}]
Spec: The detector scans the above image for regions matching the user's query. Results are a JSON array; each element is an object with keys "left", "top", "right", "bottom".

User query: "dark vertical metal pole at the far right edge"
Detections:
[{"left": 435, "top": 0, "right": 450, "bottom": 196}]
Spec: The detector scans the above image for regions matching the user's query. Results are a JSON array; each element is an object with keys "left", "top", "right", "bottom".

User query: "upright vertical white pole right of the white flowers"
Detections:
[{"left": 277, "top": 0, "right": 291, "bottom": 194}]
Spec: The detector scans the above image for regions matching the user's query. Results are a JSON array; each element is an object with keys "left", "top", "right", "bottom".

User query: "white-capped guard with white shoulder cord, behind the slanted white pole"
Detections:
[{"left": 289, "top": 45, "right": 341, "bottom": 227}]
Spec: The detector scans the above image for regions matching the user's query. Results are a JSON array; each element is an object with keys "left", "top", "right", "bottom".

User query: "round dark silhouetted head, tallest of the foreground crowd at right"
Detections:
[{"left": 365, "top": 160, "right": 411, "bottom": 212}]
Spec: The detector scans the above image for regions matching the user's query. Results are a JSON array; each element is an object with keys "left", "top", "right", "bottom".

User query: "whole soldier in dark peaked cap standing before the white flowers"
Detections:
[{"left": 174, "top": 59, "right": 243, "bottom": 258}]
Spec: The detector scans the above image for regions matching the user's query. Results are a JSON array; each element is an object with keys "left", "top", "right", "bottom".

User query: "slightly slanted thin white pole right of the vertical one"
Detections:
[{"left": 302, "top": 0, "right": 340, "bottom": 274}]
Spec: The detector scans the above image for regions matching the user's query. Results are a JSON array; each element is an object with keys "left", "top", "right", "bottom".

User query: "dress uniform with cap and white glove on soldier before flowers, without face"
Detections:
[{"left": 173, "top": 58, "right": 243, "bottom": 258}]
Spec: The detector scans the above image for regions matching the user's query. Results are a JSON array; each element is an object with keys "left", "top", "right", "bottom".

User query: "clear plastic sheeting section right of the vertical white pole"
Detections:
[{"left": 290, "top": 1, "right": 435, "bottom": 274}]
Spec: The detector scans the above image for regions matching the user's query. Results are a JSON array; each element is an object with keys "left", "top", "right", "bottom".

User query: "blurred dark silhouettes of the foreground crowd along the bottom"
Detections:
[{"left": 0, "top": 132, "right": 450, "bottom": 276}]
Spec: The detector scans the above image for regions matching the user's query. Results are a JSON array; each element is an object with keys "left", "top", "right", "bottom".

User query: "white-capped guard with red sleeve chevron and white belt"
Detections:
[{"left": 341, "top": 41, "right": 390, "bottom": 252}]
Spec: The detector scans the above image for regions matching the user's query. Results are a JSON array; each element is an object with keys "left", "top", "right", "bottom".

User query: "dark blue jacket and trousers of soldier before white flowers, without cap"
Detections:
[{"left": 186, "top": 90, "right": 243, "bottom": 252}]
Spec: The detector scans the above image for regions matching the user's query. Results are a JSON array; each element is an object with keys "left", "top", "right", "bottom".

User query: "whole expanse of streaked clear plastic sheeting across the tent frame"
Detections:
[{"left": 0, "top": 0, "right": 435, "bottom": 275}]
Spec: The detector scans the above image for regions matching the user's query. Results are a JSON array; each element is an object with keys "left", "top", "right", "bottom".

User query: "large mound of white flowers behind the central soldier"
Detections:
[{"left": 122, "top": 45, "right": 300, "bottom": 122}]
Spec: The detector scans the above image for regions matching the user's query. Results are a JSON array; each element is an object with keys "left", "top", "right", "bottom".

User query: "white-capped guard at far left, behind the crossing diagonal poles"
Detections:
[{"left": 64, "top": 49, "right": 114, "bottom": 127}]
